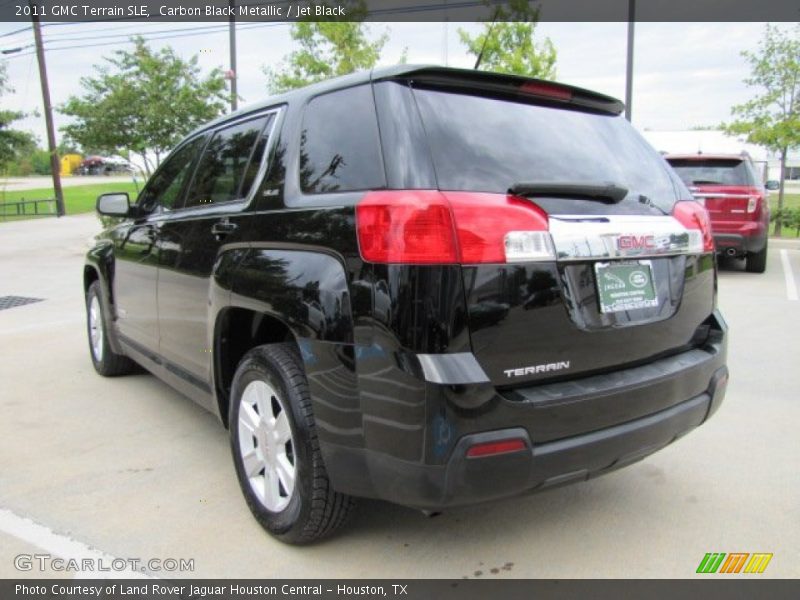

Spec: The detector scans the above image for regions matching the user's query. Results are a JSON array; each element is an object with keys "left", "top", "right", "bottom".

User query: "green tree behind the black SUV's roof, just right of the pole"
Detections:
[{"left": 264, "top": 0, "right": 388, "bottom": 93}]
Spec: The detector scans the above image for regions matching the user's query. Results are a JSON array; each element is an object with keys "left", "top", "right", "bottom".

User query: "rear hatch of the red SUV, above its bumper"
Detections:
[{"left": 667, "top": 155, "right": 763, "bottom": 227}]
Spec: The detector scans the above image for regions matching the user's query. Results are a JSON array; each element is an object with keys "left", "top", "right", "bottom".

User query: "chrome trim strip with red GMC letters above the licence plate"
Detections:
[{"left": 550, "top": 215, "right": 703, "bottom": 261}]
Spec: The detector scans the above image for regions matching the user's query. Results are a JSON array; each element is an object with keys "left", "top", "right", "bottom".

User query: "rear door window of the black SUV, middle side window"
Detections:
[{"left": 185, "top": 117, "right": 269, "bottom": 206}]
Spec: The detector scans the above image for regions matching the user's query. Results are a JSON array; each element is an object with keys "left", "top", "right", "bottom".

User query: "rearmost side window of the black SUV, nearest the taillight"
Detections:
[{"left": 299, "top": 85, "right": 385, "bottom": 194}]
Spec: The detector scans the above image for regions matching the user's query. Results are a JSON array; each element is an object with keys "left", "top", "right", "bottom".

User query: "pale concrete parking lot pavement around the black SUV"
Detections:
[{"left": 0, "top": 215, "right": 800, "bottom": 578}]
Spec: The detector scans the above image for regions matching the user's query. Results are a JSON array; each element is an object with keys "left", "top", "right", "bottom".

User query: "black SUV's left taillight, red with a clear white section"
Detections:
[{"left": 356, "top": 190, "right": 555, "bottom": 264}]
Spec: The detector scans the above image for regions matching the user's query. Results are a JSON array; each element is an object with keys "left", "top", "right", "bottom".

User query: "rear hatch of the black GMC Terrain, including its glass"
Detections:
[{"left": 386, "top": 73, "right": 715, "bottom": 388}]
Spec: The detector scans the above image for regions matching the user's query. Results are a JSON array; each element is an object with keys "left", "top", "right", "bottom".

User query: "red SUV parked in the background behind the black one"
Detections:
[{"left": 666, "top": 154, "right": 769, "bottom": 273}]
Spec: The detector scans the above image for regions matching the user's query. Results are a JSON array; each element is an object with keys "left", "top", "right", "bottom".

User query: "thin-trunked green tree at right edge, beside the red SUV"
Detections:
[{"left": 723, "top": 24, "right": 800, "bottom": 235}]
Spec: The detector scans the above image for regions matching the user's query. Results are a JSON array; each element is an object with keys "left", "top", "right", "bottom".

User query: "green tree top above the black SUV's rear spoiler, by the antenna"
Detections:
[{"left": 458, "top": 0, "right": 556, "bottom": 79}]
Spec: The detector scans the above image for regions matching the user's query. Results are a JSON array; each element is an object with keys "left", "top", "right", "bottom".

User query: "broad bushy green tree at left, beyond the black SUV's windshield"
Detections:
[{"left": 59, "top": 37, "right": 228, "bottom": 175}]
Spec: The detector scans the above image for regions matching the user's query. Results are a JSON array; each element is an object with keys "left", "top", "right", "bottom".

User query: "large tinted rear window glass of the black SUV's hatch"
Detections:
[{"left": 415, "top": 89, "right": 676, "bottom": 212}]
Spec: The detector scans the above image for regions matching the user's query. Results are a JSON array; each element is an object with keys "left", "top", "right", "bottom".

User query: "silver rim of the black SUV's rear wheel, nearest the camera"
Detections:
[{"left": 238, "top": 380, "right": 297, "bottom": 512}]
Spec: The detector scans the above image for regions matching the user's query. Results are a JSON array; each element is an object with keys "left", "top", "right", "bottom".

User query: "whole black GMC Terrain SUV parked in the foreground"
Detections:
[{"left": 83, "top": 65, "right": 728, "bottom": 543}]
